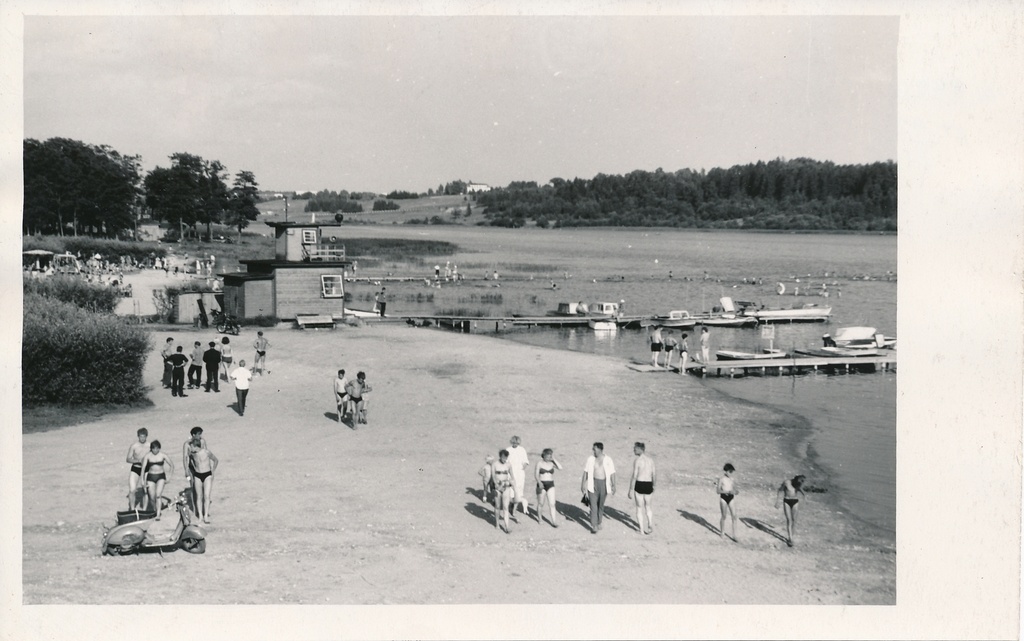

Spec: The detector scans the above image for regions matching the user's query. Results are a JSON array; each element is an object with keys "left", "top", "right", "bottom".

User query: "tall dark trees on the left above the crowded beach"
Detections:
[{"left": 23, "top": 138, "right": 259, "bottom": 238}]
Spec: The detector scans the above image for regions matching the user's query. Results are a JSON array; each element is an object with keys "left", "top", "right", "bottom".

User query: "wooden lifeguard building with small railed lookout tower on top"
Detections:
[{"left": 219, "top": 222, "right": 351, "bottom": 325}]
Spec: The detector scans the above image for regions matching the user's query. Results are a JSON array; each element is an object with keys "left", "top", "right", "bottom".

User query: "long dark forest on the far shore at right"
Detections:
[{"left": 476, "top": 158, "right": 897, "bottom": 231}]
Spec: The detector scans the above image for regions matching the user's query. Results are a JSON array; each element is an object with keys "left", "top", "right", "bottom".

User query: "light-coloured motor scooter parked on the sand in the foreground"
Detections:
[{"left": 101, "top": 488, "right": 206, "bottom": 555}]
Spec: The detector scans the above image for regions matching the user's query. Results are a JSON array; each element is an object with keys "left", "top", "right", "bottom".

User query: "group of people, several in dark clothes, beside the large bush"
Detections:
[{"left": 160, "top": 331, "right": 270, "bottom": 416}]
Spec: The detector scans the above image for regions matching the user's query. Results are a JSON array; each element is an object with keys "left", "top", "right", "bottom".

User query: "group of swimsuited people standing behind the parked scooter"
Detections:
[{"left": 125, "top": 426, "right": 220, "bottom": 523}]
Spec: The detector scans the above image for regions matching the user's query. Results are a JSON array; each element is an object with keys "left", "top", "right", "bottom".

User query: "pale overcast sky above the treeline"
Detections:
[{"left": 24, "top": 15, "right": 899, "bottom": 193}]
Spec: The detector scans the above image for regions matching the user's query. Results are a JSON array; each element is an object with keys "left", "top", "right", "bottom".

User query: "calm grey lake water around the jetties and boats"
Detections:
[{"left": 335, "top": 225, "right": 897, "bottom": 533}]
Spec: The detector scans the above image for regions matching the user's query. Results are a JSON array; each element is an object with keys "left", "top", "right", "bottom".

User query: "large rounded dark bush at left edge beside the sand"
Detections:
[{"left": 22, "top": 293, "right": 150, "bottom": 407}]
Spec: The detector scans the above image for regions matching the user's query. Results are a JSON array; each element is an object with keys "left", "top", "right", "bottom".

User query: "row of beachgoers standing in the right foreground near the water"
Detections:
[{"left": 479, "top": 436, "right": 805, "bottom": 547}]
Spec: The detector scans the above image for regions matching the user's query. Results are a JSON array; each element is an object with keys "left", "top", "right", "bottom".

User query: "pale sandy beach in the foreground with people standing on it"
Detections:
[{"left": 23, "top": 325, "right": 896, "bottom": 605}]
